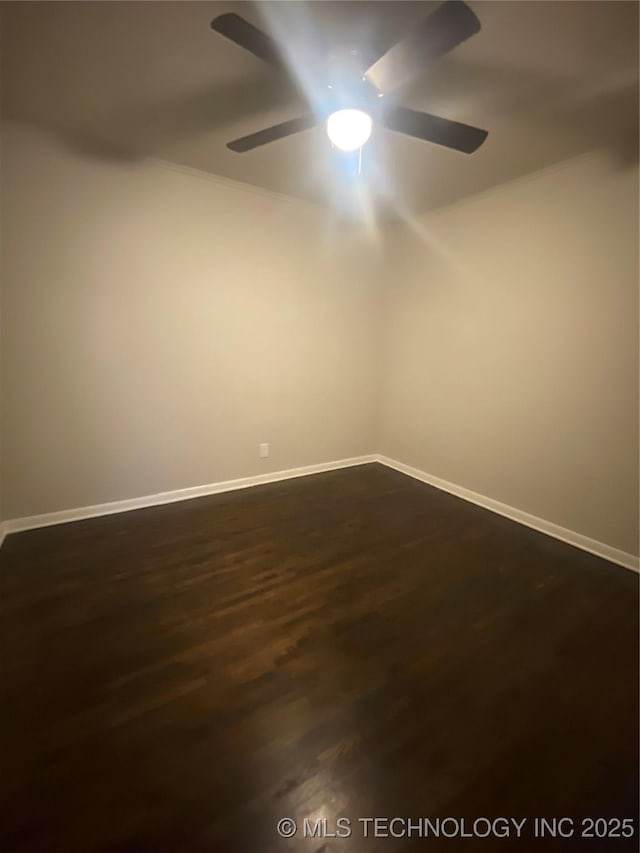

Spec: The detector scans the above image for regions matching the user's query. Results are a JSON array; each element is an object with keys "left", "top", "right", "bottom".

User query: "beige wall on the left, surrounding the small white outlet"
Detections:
[{"left": 1, "top": 125, "right": 375, "bottom": 518}]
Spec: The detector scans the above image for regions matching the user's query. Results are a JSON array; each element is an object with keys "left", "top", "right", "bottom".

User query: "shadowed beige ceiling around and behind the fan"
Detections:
[{"left": 0, "top": 0, "right": 638, "bottom": 217}]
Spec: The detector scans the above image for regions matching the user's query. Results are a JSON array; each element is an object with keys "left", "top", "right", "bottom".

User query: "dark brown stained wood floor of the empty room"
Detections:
[{"left": 0, "top": 465, "right": 638, "bottom": 853}]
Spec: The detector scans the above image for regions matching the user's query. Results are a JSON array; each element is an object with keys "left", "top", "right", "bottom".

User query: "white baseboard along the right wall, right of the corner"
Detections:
[{"left": 376, "top": 455, "right": 640, "bottom": 572}]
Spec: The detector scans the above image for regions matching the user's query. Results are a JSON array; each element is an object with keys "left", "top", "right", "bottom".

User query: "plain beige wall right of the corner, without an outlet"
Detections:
[{"left": 378, "top": 153, "right": 638, "bottom": 554}]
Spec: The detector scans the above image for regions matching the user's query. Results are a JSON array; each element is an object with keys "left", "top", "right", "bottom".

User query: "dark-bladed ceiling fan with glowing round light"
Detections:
[{"left": 211, "top": 0, "right": 488, "bottom": 154}]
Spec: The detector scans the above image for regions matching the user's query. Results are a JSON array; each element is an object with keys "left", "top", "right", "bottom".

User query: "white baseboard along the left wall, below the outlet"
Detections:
[{"left": 0, "top": 455, "right": 376, "bottom": 545}]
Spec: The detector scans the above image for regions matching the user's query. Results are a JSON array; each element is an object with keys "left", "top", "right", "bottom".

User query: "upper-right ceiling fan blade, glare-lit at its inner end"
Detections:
[{"left": 365, "top": 0, "right": 480, "bottom": 95}]
